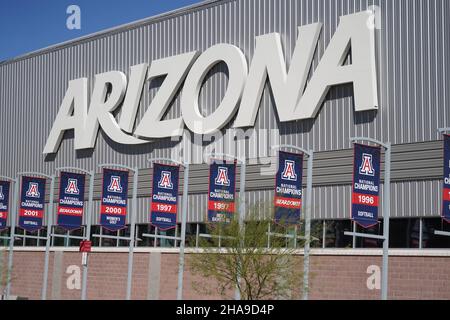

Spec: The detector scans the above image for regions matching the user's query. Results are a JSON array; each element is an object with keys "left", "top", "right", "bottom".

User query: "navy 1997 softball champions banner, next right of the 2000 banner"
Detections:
[{"left": 150, "top": 163, "right": 180, "bottom": 231}]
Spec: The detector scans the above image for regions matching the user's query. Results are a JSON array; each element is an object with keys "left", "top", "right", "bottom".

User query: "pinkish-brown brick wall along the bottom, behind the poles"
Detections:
[{"left": 4, "top": 251, "right": 450, "bottom": 300}]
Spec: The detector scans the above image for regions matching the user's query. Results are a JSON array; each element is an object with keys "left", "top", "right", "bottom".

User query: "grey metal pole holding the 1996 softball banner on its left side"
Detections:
[{"left": 381, "top": 143, "right": 391, "bottom": 300}]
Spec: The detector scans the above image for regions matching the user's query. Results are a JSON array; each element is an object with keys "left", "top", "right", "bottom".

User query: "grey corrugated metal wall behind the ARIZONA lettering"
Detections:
[{"left": 0, "top": 0, "right": 450, "bottom": 222}]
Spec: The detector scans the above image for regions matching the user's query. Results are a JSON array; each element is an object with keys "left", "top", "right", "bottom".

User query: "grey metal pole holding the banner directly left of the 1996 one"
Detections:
[{"left": 303, "top": 150, "right": 314, "bottom": 300}]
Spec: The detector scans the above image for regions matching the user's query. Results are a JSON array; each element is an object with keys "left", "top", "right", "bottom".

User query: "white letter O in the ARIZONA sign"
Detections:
[{"left": 181, "top": 44, "right": 248, "bottom": 134}]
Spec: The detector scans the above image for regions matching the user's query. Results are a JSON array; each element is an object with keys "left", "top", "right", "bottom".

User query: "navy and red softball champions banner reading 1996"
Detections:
[{"left": 352, "top": 143, "right": 381, "bottom": 228}]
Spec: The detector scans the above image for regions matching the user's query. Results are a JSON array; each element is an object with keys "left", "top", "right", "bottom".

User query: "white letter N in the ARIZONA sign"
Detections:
[{"left": 234, "top": 23, "right": 322, "bottom": 128}]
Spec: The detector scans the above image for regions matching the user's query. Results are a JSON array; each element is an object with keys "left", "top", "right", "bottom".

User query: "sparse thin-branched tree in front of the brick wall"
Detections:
[{"left": 190, "top": 204, "right": 303, "bottom": 300}]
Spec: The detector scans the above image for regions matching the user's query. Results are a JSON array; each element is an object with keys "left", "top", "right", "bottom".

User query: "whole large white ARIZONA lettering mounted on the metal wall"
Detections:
[{"left": 43, "top": 11, "right": 378, "bottom": 154}]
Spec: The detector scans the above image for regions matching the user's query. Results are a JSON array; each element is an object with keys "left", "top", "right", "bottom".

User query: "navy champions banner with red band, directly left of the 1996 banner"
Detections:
[{"left": 274, "top": 151, "right": 303, "bottom": 225}]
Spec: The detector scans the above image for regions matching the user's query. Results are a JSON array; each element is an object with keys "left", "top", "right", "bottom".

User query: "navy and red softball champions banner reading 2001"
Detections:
[{"left": 19, "top": 176, "right": 45, "bottom": 231}]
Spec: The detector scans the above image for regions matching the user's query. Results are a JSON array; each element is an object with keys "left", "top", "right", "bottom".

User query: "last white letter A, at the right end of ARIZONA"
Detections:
[{"left": 291, "top": 11, "right": 378, "bottom": 120}]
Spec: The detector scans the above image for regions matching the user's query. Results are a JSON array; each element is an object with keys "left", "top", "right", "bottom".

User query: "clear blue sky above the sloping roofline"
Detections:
[{"left": 0, "top": 0, "right": 201, "bottom": 61}]
